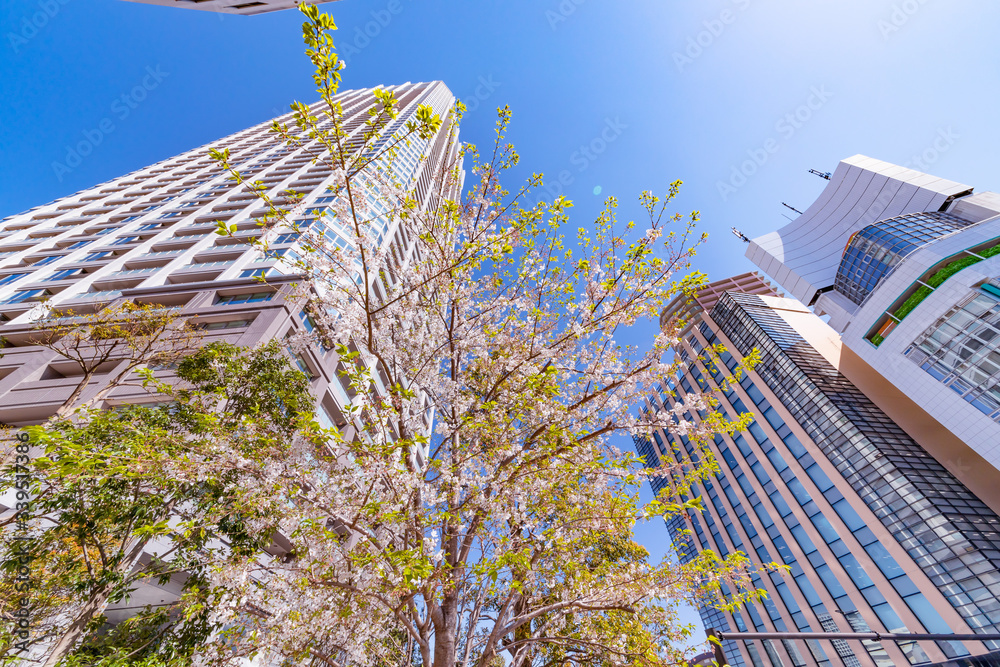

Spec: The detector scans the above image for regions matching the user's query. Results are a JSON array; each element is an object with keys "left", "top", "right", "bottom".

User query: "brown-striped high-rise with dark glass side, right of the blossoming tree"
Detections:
[{"left": 636, "top": 274, "right": 1000, "bottom": 667}]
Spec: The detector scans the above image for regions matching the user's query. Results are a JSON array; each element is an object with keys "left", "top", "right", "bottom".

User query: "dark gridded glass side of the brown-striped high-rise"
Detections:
[{"left": 712, "top": 294, "right": 1000, "bottom": 648}]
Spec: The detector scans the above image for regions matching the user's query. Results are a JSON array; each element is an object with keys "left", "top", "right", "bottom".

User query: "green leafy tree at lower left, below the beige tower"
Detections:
[{"left": 0, "top": 342, "right": 313, "bottom": 665}]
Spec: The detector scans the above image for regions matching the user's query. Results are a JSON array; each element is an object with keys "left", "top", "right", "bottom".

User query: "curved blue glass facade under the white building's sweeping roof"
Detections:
[{"left": 834, "top": 211, "right": 972, "bottom": 305}]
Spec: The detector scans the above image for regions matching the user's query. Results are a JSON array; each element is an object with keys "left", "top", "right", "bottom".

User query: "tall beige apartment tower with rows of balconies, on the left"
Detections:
[{"left": 0, "top": 82, "right": 458, "bottom": 620}]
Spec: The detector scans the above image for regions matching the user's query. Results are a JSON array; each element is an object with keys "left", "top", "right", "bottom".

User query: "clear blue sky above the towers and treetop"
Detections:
[{"left": 0, "top": 0, "right": 1000, "bottom": 648}]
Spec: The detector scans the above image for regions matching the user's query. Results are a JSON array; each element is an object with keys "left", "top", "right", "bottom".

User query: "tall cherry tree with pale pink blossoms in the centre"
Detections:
[{"left": 186, "top": 6, "right": 756, "bottom": 667}]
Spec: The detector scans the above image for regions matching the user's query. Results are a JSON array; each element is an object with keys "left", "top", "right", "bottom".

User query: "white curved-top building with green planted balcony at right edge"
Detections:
[{"left": 747, "top": 155, "right": 1000, "bottom": 490}]
